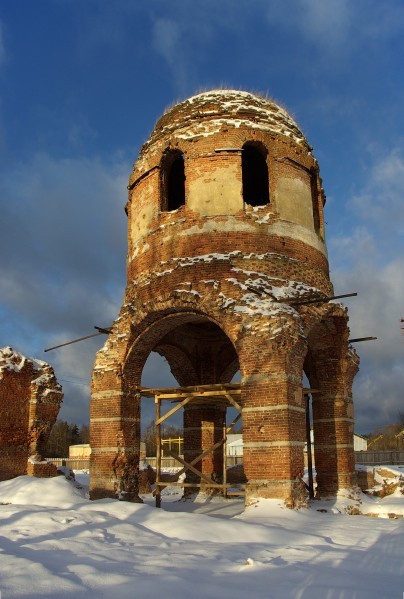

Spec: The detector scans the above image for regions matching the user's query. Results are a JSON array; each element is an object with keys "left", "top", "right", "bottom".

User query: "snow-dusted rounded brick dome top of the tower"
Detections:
[{"left": 146, "top": 89, "right": 311, "bottom": 149}]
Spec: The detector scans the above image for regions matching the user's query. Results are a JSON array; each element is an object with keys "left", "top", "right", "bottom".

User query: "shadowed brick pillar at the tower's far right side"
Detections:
[{"left": 313, "top": 346, "right": 358, "bottom": 497}]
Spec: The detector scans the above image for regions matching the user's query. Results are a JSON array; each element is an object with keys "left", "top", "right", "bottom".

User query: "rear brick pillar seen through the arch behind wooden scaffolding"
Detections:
[{"left": 184, "top": 401, "right": 226, "bottom": 496}]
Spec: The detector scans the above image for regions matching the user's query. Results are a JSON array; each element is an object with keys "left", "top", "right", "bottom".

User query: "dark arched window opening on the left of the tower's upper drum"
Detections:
[{"left": 161, "top": 150, "right": 185, "bottom": 212}]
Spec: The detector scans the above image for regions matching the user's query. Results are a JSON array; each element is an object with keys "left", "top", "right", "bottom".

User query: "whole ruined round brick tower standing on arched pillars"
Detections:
[{"left": 90, "top": 90, "right": 358, "bottom": 501}]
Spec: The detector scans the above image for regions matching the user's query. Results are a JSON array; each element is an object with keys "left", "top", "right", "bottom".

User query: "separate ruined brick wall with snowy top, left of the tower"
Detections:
[{"left": 0, "top": 347, "right": 63, "bottom": 480}]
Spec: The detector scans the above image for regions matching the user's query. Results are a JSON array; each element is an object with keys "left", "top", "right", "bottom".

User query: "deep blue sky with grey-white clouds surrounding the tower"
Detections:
[{"left": 0, "top": 0, "right": 404, "bottom": 432}]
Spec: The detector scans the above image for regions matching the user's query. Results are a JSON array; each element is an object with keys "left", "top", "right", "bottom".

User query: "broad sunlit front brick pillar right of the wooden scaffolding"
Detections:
[{"left": 240, "top": 335, "right": 305, "bottom": 506}]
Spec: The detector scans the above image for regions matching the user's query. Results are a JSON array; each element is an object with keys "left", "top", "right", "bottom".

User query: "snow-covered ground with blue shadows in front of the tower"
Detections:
[{"left": 0, "top": 469, "right": 404, "bottom": 599}]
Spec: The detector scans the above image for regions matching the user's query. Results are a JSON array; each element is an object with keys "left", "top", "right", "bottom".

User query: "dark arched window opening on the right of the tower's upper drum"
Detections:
[{"left": 241, "top": 143, "right": 269, "bottom": 206}]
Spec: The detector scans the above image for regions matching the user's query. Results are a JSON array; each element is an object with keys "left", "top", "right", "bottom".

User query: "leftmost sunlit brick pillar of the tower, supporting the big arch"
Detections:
[{"left": 90, "top": 365, "right": 140, "bottom": 501}]
